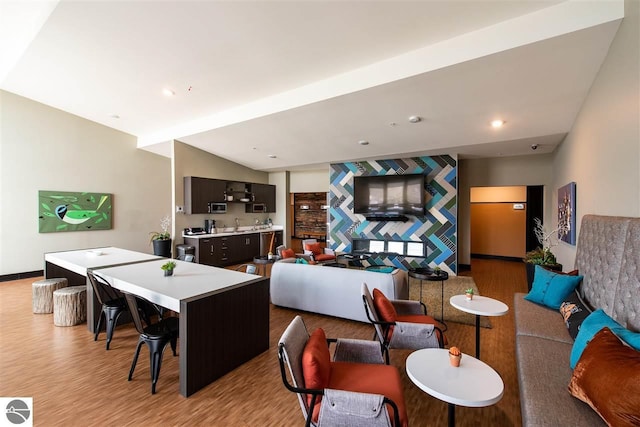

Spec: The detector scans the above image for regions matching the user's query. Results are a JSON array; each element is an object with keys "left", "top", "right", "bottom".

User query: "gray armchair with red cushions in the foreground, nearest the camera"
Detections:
[{"left": 278, "top": 316, "right": 408, "bottom": 427}]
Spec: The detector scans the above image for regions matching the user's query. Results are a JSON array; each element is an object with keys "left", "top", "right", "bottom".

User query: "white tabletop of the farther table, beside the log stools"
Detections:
[{"left": 44, "top": 247, "right": 161, "bottom": 276}]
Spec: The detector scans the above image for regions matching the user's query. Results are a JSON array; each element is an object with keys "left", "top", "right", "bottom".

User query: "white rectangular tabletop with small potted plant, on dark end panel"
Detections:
[{"left": 93, "top": 258, "right": 261, "bottom": 313}]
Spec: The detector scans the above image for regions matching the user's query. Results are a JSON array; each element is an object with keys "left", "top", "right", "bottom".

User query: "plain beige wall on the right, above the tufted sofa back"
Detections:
[{"left": 552, "top": 0, "right": 640, "bottom": 269}]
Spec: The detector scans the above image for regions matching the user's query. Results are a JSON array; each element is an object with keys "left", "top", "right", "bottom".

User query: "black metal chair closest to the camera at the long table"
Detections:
[{"left": 123, "top": 292, "right": 179, "bottom": 394}]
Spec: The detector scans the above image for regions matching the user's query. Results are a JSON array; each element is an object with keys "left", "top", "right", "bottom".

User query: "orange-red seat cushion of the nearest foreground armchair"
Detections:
[{"left": 328, "top": 362, "right": 409, "bottom": 426}]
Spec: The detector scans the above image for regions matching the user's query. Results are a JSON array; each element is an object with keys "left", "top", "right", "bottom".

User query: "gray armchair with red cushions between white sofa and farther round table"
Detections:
[{"left": 362, "top": 283, "right": 446, "bottom": 364}]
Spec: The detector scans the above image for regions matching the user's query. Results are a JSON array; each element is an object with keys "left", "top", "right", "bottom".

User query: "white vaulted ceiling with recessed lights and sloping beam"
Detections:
[{"left": 0, "top": 0, "right": 624, "bottom": 171}]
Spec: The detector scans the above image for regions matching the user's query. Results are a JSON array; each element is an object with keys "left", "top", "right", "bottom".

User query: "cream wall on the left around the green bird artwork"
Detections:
[{"left": 0, "top": 91, "right": 171, "bottom": 275}]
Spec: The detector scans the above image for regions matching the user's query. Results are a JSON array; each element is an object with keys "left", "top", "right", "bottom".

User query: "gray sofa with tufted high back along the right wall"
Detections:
[{"left": 514, "top": 215, "right": 640, "bottom": 426}]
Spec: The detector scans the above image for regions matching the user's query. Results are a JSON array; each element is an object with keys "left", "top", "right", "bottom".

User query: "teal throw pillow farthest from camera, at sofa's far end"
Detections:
[{"left": 524, "top": 265, "right": 582, "bottom": 310}]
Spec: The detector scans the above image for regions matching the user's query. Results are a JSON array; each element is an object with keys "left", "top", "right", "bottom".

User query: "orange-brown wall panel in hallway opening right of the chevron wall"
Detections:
[{"left": 471, "top": 203, "right": 527, "bottom": 258}]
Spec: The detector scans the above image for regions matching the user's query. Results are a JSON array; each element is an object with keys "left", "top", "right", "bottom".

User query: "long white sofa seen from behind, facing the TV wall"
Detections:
[{"left": 271, "top": 261, "right": 409, "bottom": 323}]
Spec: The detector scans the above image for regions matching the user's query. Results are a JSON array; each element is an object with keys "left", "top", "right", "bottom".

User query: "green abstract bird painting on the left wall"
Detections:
[{"left": 38, "top": 191, "right": 112, "bottom": 233}]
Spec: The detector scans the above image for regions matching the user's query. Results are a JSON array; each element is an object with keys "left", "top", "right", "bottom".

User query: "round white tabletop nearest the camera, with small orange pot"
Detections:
[{"left": 406, "top": 348, "right": 504, "bottom": 408}]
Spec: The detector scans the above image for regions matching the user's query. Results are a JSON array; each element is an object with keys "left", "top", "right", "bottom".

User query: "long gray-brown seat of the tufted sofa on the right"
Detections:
[{"left": 516, "top": 336, "right": 605, "bottom": 427}]
